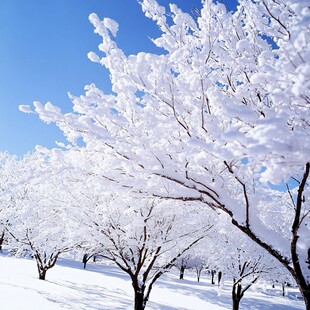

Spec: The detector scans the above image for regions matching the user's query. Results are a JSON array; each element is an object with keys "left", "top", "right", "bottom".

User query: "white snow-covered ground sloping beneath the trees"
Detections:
[{"left": 0, "top": 255, "right": 304, "bottom": 310}]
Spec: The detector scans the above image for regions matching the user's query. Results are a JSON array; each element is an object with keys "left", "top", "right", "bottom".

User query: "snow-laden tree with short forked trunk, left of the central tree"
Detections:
[{"left": 6, "top": 152, "right": 78, "bottom": 280}]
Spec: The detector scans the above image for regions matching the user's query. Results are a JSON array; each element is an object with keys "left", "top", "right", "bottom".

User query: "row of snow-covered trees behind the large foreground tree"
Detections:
[{"left": 0, "top": 149, "right": 291, "bottom": 310}]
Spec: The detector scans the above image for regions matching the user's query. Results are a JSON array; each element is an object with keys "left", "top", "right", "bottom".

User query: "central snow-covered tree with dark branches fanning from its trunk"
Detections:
[{"left": 38, "top": 148, "right": 216, "bottom": 309}]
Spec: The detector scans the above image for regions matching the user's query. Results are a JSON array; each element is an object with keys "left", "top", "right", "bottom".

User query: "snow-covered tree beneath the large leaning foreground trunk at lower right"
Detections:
[{"left": 188, "top": 218, "right": 292, "bottom": 310}]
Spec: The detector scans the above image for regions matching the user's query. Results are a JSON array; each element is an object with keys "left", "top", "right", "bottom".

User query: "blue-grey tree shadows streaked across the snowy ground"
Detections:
[{"left": 48, "top": 259, "right": 302, "bottom": 310}]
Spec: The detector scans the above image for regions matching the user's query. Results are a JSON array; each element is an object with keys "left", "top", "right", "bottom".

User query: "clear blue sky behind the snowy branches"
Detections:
[{"left": 0, "top": 0, "right": 232, "bottom": 155}]
